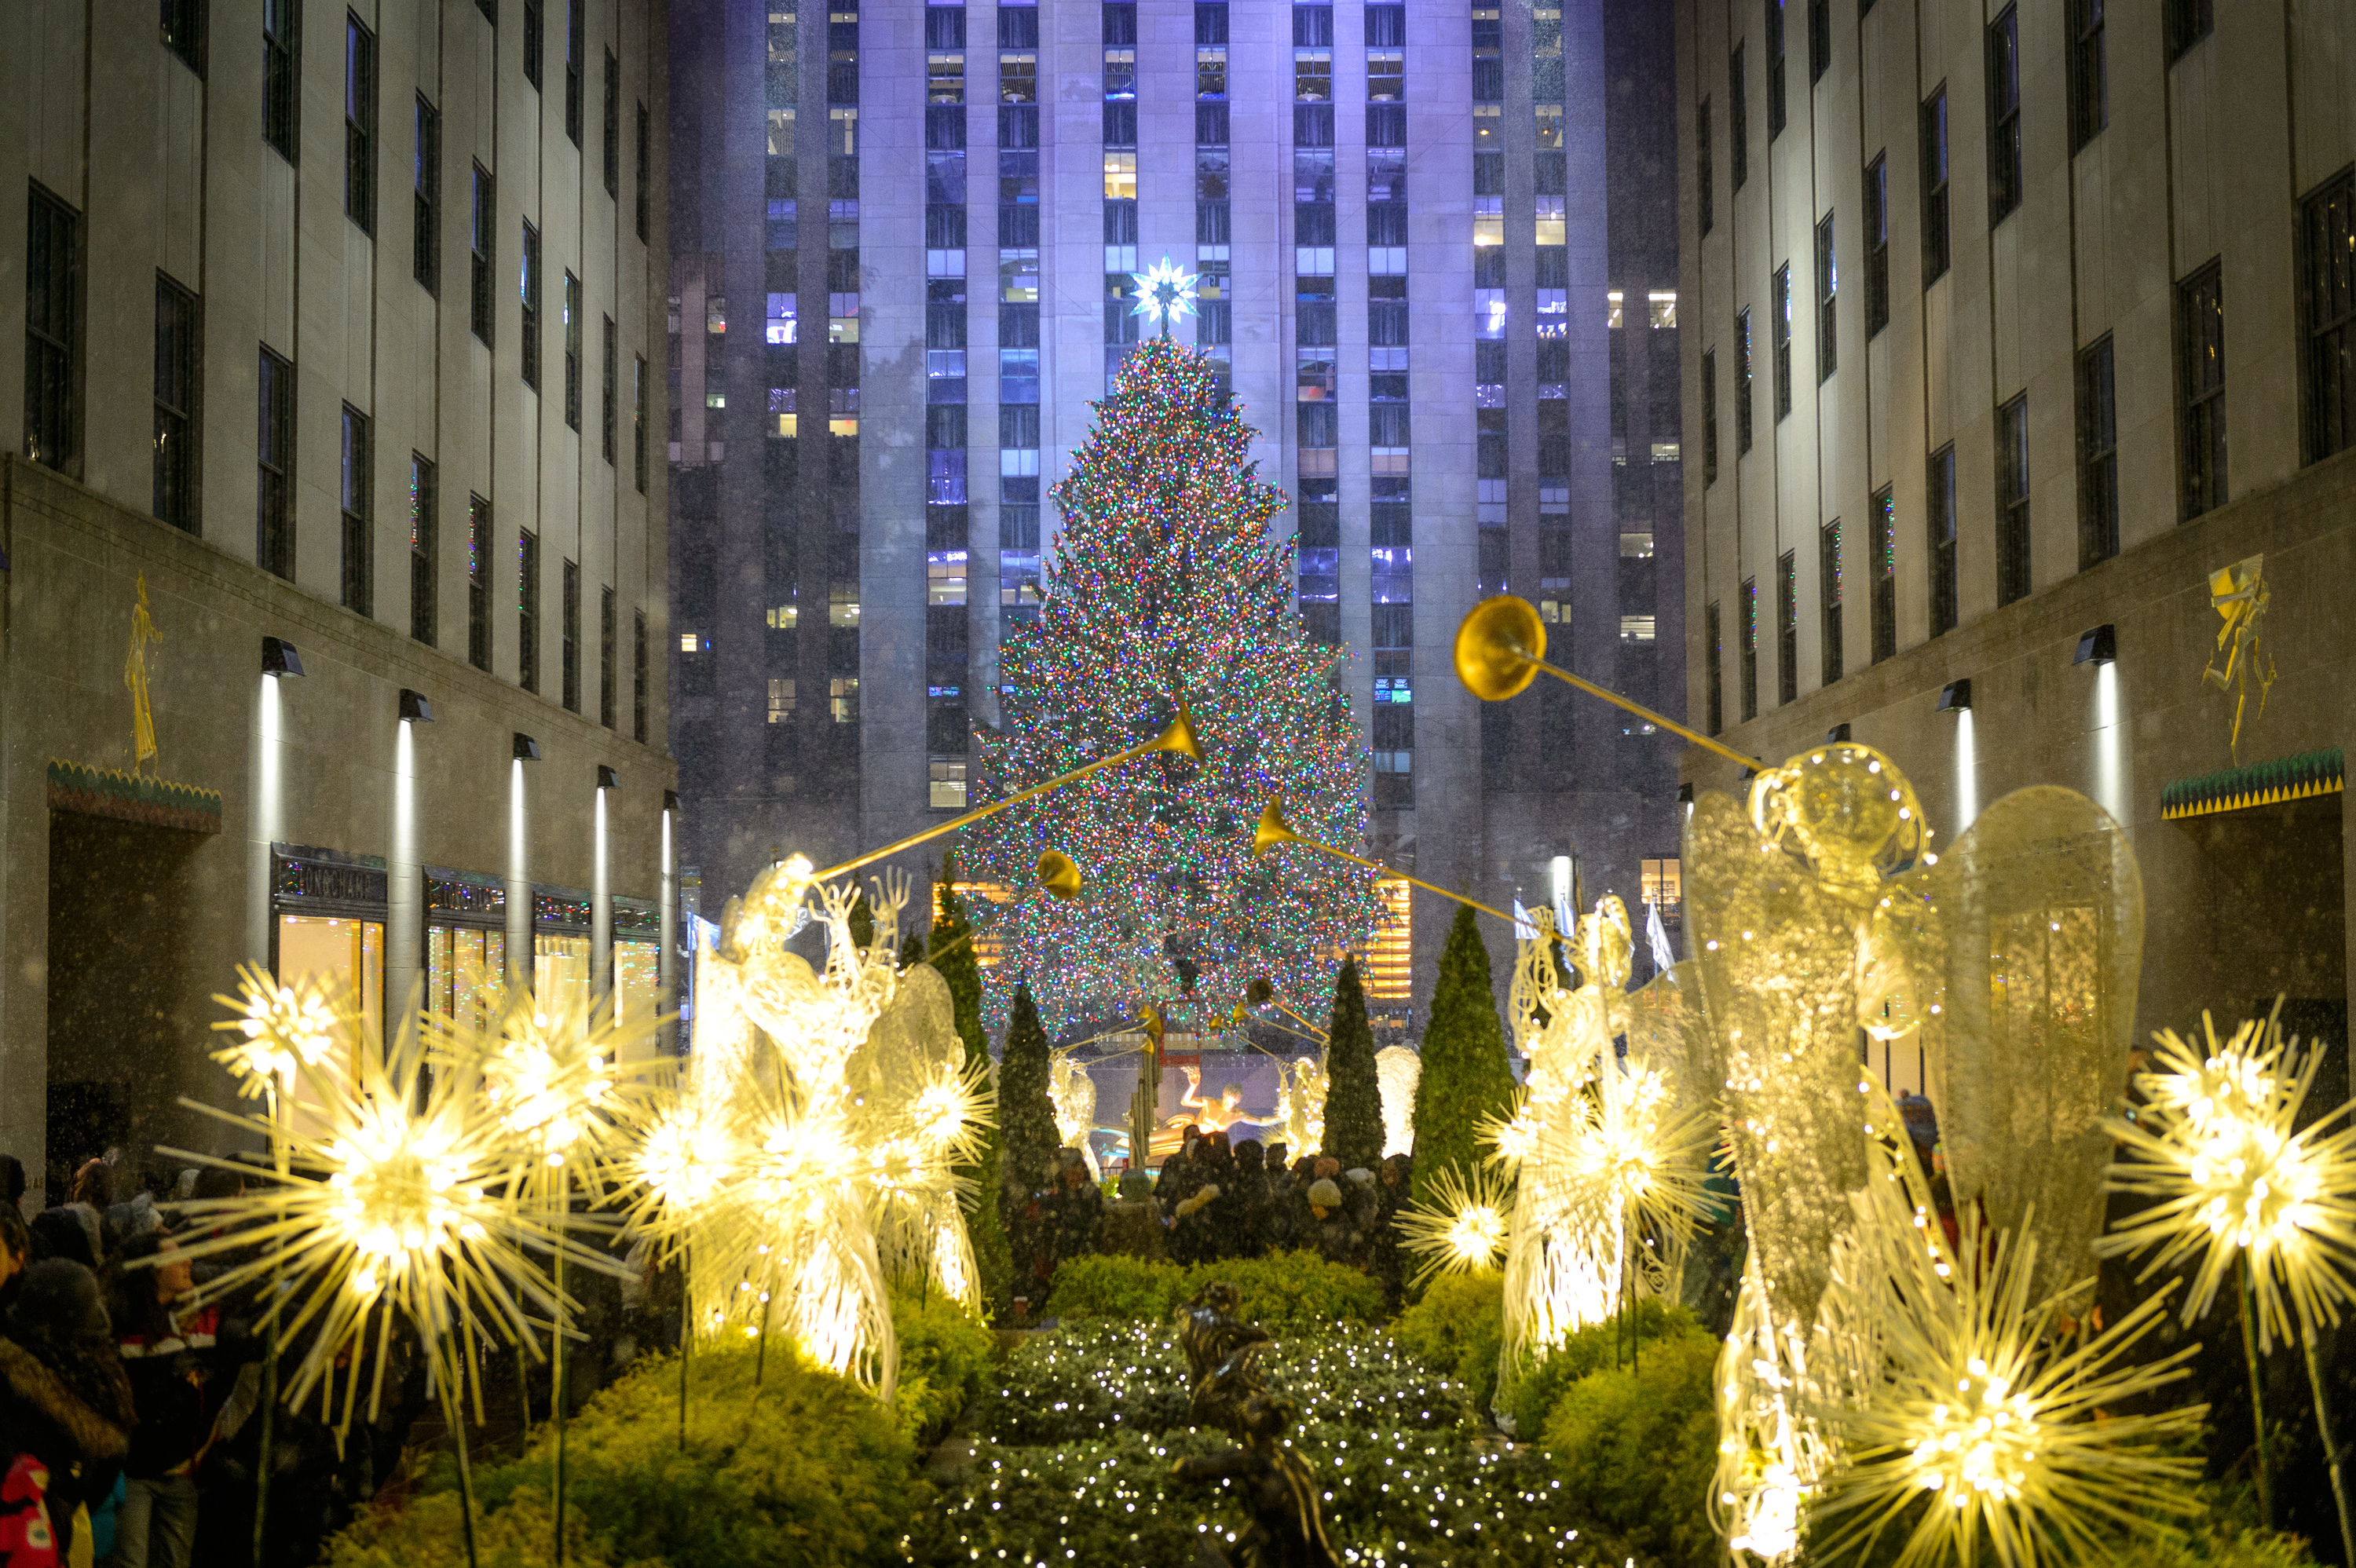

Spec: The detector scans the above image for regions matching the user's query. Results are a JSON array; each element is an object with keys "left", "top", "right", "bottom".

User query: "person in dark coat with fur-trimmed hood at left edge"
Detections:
[{"left": 0, "top": 1257, "right": 139, "bottom": 1563}]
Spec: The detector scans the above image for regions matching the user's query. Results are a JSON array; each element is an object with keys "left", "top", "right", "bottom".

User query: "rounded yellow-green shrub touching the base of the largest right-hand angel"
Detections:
[{"left": 1543, "top": 1330, "right": 1722, "bottom": 1568}]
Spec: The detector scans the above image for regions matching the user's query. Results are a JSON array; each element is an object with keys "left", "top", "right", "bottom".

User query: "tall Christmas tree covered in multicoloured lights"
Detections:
[{"left": 966, "top": 339, "right": 1374, "bottom": 1031}]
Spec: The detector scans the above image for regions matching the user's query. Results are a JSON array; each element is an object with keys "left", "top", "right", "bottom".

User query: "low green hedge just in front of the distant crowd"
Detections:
[{"left": 1046, "top": 1252, "right": 1383, "bottom": 1332}]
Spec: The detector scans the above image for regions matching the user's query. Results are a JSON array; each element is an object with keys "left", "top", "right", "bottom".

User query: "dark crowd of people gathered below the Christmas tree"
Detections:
[{"left": 1011, "top": 1123, "right": 1414, "bottom": 1309}]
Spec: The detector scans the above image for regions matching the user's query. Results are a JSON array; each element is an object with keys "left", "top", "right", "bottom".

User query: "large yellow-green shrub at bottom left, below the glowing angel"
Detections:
[{"left": 327, "top": 1347, "right": 931, "bottom": 1568}]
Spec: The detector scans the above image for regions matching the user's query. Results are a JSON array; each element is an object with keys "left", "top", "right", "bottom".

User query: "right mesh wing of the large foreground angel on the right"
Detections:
[{"left": 1927, "top": 786, "right": 2144, "bottom": 1297}]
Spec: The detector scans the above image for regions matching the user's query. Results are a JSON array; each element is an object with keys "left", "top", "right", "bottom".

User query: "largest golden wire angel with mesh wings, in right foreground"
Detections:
[{"left": 1687, "top": 744, "right": 2142, "bottom": 1561}]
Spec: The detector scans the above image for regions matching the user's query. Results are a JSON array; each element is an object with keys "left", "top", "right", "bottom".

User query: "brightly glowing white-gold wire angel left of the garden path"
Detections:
[{"left": 664, "top": 857, "right": 990, "bottom": 1401}]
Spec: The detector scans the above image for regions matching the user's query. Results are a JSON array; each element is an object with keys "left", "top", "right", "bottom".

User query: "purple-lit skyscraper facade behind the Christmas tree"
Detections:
[{"left": 671, "top": 0, "right": 1682, "bottom": 1022}]
